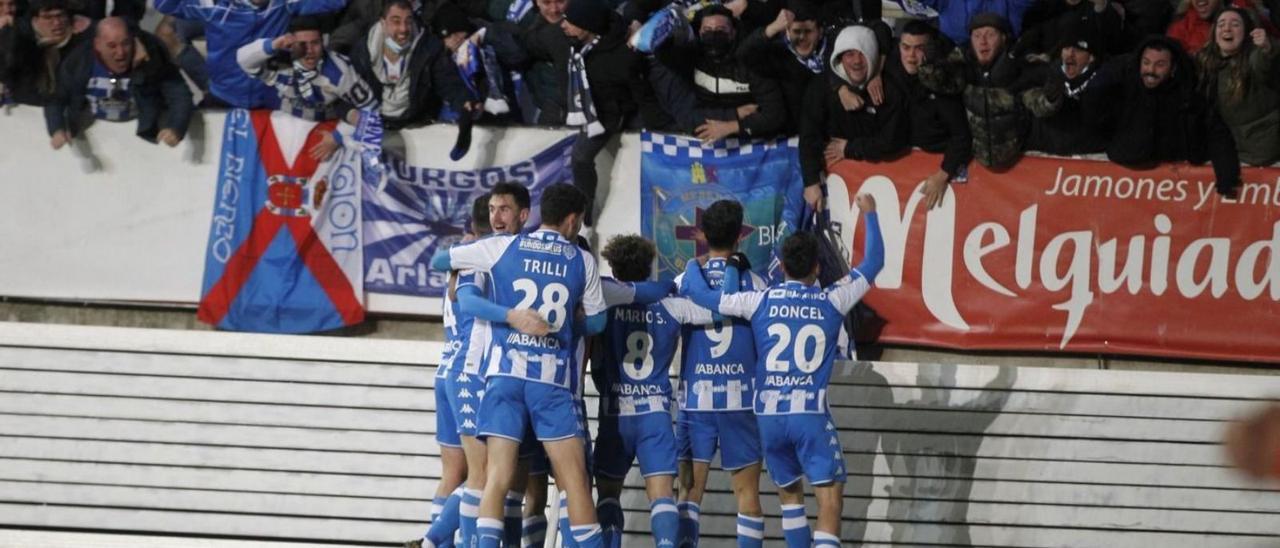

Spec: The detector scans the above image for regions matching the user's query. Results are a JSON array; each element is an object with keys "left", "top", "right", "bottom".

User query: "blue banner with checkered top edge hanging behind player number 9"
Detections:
[{"left": 640, "top": 132, "right": 804, "bottom": 282}]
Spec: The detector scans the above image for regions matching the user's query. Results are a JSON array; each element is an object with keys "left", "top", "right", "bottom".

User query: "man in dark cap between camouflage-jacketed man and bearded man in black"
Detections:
[{"left": 1023, "top": 31, "right": 1108, "bottom": 156}]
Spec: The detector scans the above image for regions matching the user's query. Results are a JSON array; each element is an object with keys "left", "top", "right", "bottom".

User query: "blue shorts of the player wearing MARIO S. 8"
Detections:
[{"left": 595, "top": 412, "right": 676, "bottom": 479}]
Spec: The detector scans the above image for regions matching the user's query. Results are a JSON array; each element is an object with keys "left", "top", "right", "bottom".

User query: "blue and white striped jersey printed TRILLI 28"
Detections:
[{"left": 449, "top": 230, "right": 605, "bottom": 389}]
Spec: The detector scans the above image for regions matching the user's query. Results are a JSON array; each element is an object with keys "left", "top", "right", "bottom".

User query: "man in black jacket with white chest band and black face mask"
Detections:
[{"left": 650, "top": 3, "right": 786, "bottom": 142}]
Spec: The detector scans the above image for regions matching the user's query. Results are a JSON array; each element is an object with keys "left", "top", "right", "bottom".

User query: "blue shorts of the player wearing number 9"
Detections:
[{"left": 676, "top": 411, "right": 760, "bottom": 471}]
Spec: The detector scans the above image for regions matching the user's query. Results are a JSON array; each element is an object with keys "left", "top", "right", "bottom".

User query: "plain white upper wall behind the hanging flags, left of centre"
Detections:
[{"left": 0, "top": 108, "right": 640, "bottom": 315}]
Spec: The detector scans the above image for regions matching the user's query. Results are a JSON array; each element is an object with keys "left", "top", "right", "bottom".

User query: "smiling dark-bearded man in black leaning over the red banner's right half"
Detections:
[{"left": 1084, "top": 36, "right": 1240, "bottom": 195}]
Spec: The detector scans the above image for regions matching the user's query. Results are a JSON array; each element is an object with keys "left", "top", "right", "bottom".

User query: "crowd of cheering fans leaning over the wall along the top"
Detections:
[{"left": 0, "top": 0, "right": 1280, "bottom": 209}]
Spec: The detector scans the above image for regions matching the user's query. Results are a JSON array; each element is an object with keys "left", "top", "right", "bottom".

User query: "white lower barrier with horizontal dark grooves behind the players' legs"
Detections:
[{"left": 0, "top": 323, "right": 1280, "bottom": 548}]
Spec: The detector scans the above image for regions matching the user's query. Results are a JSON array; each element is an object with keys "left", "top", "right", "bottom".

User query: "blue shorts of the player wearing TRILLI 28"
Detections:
[{"left": 477, "top": 375, "right": 581, "bottom": 443}]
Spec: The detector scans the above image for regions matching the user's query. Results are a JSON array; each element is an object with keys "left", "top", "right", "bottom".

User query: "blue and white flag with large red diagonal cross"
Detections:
[{"left": 197, "top": 109, "right": 381, "bottom": 333}]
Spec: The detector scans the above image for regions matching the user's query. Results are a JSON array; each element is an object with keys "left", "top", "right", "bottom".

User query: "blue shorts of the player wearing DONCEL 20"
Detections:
[{"left": 758, "top": 414, "right": 845, "bottom": 487}]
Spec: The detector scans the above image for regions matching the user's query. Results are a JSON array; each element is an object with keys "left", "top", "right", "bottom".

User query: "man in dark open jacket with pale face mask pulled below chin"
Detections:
[{"left": 351, "top": 0, "right": 467, "bottom": 129}]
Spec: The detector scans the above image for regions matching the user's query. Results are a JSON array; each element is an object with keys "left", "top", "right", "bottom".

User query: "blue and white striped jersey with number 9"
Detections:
[{"left": 676, "top": 259, "right": 767, "bottom": 411}]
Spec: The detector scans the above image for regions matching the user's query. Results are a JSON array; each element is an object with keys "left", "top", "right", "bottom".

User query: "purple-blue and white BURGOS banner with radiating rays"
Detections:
[{"left": 364, "top": 136, "right": 573, "bottom": 297}]
